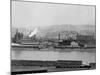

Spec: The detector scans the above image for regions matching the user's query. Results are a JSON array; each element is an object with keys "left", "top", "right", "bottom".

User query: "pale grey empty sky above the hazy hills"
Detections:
[{"left": 11, "top": 1, "right": 95, "bottom": 27}]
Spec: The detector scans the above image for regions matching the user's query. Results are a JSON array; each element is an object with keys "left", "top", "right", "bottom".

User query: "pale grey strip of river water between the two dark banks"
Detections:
[{"left": 11, "top": 48, "right": 96, "bottom": 63}]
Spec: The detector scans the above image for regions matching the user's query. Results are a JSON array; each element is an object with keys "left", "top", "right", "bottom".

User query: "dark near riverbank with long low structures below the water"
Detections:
[{"left": 11, "top": 60, "right": 95, "bottom": 74}]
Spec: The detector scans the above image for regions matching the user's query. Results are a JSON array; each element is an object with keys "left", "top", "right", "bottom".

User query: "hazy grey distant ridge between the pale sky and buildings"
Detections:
[{"left": 12, "top": 24, "right": 95, "bottom": 37}]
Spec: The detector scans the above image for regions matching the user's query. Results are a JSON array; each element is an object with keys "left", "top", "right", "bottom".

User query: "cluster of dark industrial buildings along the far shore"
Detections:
[{"left": 12, "top": 29, "right": 96, "bottom": 47}]
